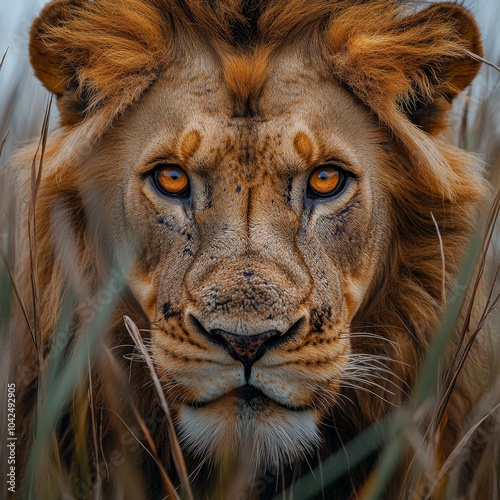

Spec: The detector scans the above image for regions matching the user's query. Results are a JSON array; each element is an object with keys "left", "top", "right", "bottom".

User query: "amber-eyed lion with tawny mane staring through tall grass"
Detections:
[{"left": 2, "top": 0, "right": 487, "bottom": 499}]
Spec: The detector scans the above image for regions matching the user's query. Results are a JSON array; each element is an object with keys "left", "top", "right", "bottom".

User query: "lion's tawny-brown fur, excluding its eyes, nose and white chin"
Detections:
[{"left": 2, "top": 0, "right": 484, "bottom": 498}]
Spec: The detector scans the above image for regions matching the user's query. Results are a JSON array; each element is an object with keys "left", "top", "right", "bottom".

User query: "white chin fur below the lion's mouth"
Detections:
[{"left": 177, "top": 401, "right": 320, "bottom": 469}]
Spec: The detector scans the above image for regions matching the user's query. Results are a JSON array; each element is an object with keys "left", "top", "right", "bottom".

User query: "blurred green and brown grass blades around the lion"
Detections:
[{"left": 0, "top": 1, "right": 500, "bottom": 500}]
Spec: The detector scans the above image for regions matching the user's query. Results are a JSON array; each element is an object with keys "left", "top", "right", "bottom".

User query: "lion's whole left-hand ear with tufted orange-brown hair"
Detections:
[{"left": 30, "top": 0, "right": 171, "bottom": 126}]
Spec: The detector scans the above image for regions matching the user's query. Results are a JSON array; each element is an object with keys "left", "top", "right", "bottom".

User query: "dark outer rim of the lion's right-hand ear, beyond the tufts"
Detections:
[{"left": 403, "top": 3, "right": 483, "bottom": 133}]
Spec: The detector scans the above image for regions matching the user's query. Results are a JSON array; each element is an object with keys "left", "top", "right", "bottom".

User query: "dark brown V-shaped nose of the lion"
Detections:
[{"left": 190, "top": 315, "right": 305, "bottom": 379}]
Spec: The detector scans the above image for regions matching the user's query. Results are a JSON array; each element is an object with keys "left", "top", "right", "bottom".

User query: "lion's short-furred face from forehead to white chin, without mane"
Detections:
[{"left": 89, "top": 52, "right": 394, "bottom": 465}]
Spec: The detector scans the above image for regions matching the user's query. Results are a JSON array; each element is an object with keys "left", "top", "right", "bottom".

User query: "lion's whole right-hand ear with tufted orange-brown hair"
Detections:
[{"left": 329, "top": 1, "right": 482, "bottom": 134}]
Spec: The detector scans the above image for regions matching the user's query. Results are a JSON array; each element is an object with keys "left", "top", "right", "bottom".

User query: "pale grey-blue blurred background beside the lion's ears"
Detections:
[{"left": 0, "top": 0, "right": 500, "bottom": 163}]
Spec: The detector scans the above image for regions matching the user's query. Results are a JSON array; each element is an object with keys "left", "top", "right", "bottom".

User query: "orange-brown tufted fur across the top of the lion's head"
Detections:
[{"left": 31, "top": 0, "right": 480, "bottom": 116}]
